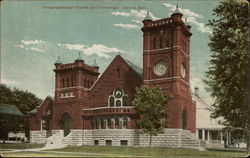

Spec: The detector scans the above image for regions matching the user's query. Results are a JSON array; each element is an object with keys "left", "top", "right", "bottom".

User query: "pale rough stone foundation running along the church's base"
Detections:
[{"left": 30, "top": 129, "right": 204, "bottom": 149}]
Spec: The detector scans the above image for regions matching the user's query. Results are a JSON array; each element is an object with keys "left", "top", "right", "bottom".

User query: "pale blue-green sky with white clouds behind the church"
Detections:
[{"left": 0, "top": 0, "right": 219, "bottom": 103}]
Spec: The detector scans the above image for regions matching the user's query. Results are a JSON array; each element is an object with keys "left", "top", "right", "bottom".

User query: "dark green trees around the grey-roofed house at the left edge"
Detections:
[{"left": 0, "top": 84, "right": 42, "bottom": 140}]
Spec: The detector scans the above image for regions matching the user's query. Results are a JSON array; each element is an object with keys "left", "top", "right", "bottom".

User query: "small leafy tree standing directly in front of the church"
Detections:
[{"left": 132, "top": 86, "right": 168, "bottom": 147}]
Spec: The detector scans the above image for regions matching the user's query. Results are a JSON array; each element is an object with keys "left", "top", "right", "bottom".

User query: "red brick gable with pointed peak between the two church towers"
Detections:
[{"left": 89, "top": 55, "right": 143, "bottom": 108}]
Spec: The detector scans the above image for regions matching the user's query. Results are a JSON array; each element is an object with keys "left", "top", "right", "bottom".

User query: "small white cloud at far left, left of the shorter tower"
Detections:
[{"left": 15, "top": 39, "right": 47, "bottom": 52}]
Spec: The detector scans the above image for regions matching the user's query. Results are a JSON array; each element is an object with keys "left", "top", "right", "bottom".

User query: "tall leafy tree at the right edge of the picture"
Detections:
[{"left": 204, "top": 0, "right": 250, "bottom": 152}]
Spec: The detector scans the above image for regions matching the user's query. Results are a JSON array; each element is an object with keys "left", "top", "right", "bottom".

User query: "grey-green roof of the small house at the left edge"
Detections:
[{"left": 0, "top": 103, "right": 23, "bottom": 116}]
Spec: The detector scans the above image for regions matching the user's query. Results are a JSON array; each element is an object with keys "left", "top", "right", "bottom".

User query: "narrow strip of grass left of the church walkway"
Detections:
[{"left": 0, "top": 143, "right": 44, "bottom": 150}]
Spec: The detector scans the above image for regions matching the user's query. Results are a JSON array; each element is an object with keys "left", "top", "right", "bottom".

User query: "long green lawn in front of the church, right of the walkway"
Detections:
[{"left": 47, "top": 146, "right": 246, "bottom": 157}]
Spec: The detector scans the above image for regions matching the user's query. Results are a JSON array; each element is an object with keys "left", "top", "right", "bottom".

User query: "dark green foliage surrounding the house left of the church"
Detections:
[{"left": 0, "top": 84, "right": 42, "bottom": 137}]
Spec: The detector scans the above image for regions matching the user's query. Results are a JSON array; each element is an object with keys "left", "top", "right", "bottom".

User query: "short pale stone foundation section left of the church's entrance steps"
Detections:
[{"left": 30, "top": 130, "right": 47, "bottom": 144}]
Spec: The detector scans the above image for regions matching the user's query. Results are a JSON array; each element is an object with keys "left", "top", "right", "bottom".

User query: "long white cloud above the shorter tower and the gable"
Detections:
[{"left": 58, "top": 43, "right": 124, "bottom": 58}]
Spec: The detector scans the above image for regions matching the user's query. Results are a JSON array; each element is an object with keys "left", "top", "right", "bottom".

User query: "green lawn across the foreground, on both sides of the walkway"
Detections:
[{"left": 0, "top": 144, "right": 246, "bottom": 157}]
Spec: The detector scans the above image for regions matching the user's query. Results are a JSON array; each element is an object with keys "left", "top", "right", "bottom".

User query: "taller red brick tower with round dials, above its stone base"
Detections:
[{"left": 141, "top": 6, "right": 195, "bottom": 132}]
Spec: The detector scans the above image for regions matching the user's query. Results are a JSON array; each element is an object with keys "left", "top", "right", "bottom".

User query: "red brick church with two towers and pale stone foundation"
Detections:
[{"left": 30, "top": 7, "right": 199, "bottom": 148}]
